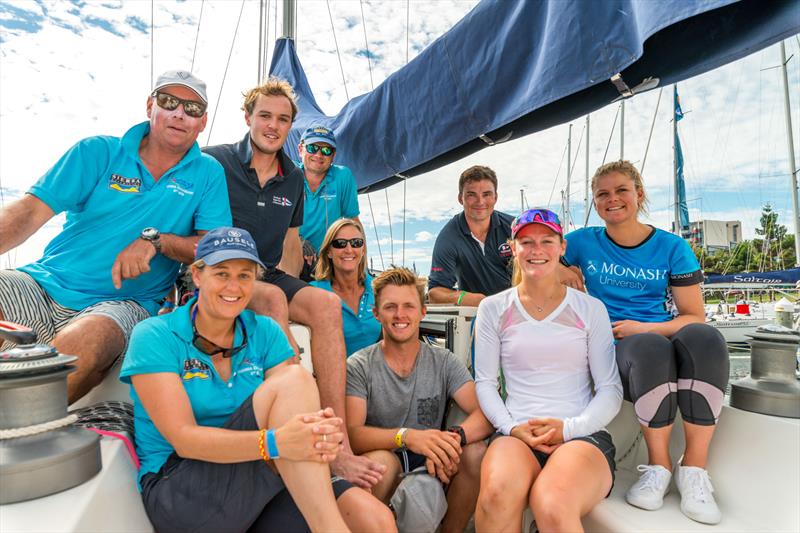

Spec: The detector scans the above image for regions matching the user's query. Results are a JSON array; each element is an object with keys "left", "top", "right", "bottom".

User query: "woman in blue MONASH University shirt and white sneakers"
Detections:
[{"left": 562, "top": 161, "right": 729, "bottom": 524}]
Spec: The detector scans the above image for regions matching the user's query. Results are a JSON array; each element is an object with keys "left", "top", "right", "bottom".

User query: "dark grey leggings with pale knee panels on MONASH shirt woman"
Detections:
[{"left": 617, "top": 324, "right": 730, "bottom": 428}]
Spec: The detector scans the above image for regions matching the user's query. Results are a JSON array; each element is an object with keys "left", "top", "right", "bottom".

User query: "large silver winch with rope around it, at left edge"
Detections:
[{"left": 0, "top": 321, "right": 102, "bottom": 504}]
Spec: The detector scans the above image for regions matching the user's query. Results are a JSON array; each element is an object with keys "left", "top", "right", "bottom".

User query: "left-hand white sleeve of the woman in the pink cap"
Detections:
[{"left": 475, "top": 293, "right": 515, "bottom": 435}]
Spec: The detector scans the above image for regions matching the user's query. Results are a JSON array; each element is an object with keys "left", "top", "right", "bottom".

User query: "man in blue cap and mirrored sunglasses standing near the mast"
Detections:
[{"left": 297, "top": 125, "right": 361, "bottom": 258}]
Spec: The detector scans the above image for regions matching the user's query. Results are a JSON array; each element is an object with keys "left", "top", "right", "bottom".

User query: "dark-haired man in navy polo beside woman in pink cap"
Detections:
[{"left": 428, "top": 165, "right": 513, "bottom": 306}]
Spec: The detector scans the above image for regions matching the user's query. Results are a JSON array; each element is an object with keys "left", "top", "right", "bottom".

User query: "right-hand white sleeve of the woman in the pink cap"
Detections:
[{"left": 564, "top": 297, "right": 622, "bottom": 441}]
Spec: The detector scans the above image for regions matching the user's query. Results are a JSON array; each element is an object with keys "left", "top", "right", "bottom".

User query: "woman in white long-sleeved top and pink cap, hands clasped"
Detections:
[{"left": 475, "top": 209, "right": 622, "bottom": 533}]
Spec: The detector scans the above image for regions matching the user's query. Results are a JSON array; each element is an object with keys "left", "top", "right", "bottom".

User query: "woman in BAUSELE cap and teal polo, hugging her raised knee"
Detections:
[{"left": 121, "top": 228, "right": 394, "bottom": 532}]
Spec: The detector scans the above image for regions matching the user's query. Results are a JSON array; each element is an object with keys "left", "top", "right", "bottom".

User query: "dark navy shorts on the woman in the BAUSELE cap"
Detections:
[{"left": 141, "top": 396, "right": 353, "bottom": 533}]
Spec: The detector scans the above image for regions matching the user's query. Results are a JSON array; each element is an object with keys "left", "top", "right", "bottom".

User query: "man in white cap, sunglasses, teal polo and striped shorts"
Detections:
[{"left": 0, "top": 71, "right": 231, "bottom": 402}]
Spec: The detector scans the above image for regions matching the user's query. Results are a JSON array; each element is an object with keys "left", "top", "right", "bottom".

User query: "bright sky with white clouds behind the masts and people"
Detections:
[{"left": 0, "top": 0, "right": 800, "bottom": 273}]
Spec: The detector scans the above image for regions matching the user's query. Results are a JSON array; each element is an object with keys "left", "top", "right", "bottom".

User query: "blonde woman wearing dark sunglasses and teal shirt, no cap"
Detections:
[{"left": 311, "top": 218, "right": 381, "bottom": 357}]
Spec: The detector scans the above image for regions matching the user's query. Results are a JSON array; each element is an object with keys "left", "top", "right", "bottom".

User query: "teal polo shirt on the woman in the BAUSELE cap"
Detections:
[{"left": 120, "top": 298, "right": 294, "bottom": 480}]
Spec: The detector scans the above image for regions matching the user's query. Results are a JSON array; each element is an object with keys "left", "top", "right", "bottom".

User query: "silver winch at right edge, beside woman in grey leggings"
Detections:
[{"left": 731, "top": 325, "right": 800, "bottom": 418}]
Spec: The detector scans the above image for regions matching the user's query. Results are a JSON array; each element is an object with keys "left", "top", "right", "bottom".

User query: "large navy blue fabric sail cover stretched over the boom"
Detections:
[{"left": 270, "top": 0, "right": 800, "bottom": 192}]
